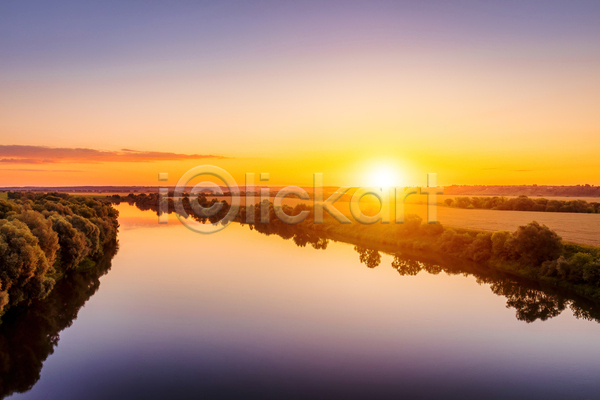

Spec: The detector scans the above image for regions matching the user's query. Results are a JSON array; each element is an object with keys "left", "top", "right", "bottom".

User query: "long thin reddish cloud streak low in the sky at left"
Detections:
[{"left": 0, "top": 145, "right": 228, "bottom": 164}]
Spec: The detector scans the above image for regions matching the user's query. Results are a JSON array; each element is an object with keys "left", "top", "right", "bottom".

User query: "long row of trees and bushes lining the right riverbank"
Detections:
[{"left": 115, "top": 194, "right": 600, "bottom": 299}]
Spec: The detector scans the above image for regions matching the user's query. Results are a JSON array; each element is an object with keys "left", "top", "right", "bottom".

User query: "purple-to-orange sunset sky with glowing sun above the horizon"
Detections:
[{"left": 0, "top": 0, "right": 600, "bottom": 186}]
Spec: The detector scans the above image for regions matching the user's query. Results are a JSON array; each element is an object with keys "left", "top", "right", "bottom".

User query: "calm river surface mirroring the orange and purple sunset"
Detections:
[{"left": 0, "top": 205, "right": 600, "bottom": 399}]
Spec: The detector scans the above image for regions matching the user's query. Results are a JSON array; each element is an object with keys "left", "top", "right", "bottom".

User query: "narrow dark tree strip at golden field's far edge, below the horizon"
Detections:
[{"left": 444, "top": 196, "right": 600, "bottom": 213}]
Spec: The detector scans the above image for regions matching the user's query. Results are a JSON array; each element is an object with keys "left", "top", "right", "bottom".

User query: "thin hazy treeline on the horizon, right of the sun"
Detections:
[{"left": 444, "top": 184, "right": 600, "bottom": 197}]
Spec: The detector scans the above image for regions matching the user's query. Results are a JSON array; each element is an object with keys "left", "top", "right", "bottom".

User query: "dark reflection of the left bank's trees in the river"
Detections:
[{"left": 0, "top": 243, "right": 117, "bottom": 398}]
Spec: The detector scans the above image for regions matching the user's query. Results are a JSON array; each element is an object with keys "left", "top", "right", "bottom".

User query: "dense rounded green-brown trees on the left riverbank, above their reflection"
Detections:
[{"left": 0, "top": 192, "right": 119, "bottom": 315}]
